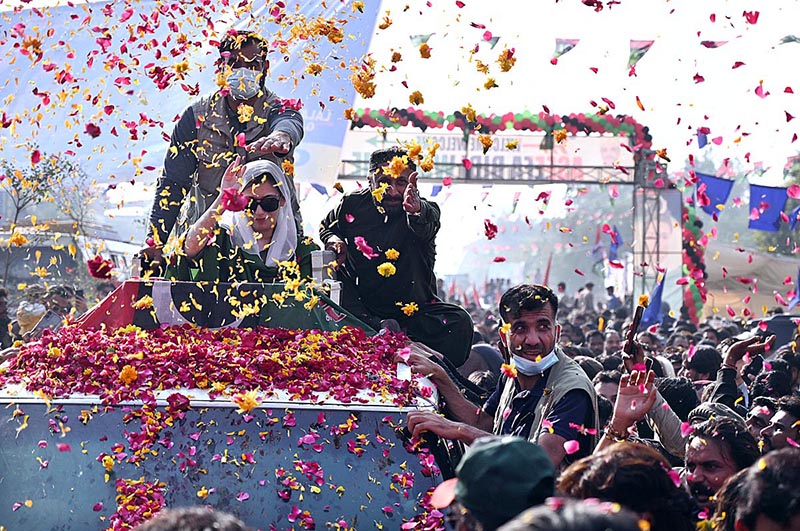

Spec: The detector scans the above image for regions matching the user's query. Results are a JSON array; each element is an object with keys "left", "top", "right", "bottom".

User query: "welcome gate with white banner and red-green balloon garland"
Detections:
[{"left": 338, "top": 108, "right": 682, "bottom": 300}]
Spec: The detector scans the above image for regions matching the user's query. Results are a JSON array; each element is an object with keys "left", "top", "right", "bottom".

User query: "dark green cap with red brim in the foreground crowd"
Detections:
[{"left": 431, "top": 437, "right": 555, "bottom": 527}]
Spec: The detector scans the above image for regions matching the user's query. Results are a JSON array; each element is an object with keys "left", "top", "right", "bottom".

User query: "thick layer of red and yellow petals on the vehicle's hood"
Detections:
[{"left": 0, "top": 325, "right": 412, "bottom": 406}]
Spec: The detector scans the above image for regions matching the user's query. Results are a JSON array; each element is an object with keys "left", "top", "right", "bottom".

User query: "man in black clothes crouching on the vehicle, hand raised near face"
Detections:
[{"left": 319, "top": 147, "right": 473, "bottom": 367}]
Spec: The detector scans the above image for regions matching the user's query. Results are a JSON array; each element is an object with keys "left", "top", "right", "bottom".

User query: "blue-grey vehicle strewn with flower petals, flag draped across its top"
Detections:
[{"left": 0, "top": 281, "right": 450, "bottom": 531}]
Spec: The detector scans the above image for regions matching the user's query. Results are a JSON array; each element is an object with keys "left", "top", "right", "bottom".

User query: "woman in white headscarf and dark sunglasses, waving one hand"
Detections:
[{"left": 168, "top": 158, "right": 319, "bottom": 282}]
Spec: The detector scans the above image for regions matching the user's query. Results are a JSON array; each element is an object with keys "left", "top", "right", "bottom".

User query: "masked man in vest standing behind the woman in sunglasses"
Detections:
[{"left": 141, "top": 31, "right": 303, "bottom": 272}]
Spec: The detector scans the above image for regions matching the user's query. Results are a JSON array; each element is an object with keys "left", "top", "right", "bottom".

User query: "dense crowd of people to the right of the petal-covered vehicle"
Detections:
[{"left": 408, "top": 278, "right": 800, "bottom": 531}]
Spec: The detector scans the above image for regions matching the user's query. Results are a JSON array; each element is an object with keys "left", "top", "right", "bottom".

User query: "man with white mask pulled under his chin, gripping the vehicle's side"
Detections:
[{"left": 408, "top": 284, "right": 598, "bottom": 468}]
